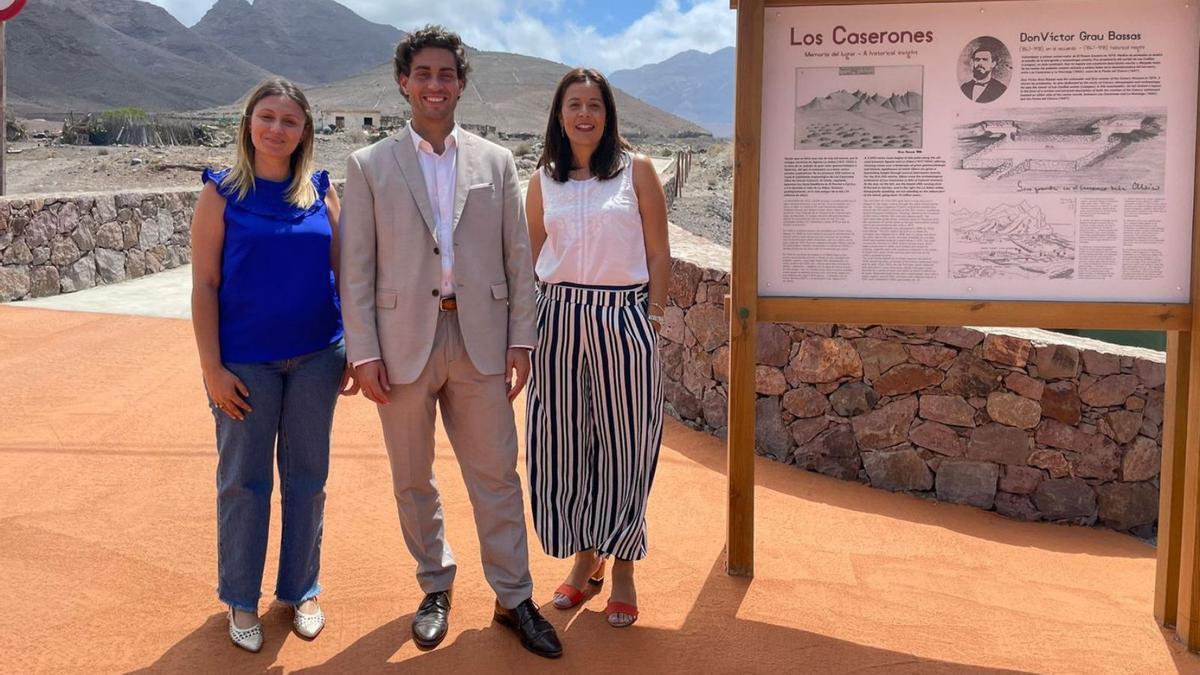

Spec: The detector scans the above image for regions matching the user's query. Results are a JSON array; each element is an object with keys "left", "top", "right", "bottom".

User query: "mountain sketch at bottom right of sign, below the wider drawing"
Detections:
[{"left": 950, "top": 197, "right": 1075, "bottom": 280}]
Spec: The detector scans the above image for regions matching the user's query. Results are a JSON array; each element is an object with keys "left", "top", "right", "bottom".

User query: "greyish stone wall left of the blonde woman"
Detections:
[{"left": 0, "top": 189, "right": 199, "bottom": 301}]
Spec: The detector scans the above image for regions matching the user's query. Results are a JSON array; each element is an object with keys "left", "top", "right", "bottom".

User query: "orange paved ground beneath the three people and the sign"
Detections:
[{"left": 0, "top": 306, "right": 1200, "bottom": 674}]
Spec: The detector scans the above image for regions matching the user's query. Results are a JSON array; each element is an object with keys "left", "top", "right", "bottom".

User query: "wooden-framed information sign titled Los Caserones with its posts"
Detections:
[{"left": 727, "top": 0, "right": 1200, "bottom": 650}]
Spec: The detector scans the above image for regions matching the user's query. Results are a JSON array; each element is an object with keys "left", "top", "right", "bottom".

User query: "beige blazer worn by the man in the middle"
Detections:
[{"left": 340, "top": 127, "right": 538, "bottom": 384}]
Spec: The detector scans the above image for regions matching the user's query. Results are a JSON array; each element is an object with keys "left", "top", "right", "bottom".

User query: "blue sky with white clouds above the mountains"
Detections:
[{"left": 149, "top": 0, "right": 736, "bottom": 72}]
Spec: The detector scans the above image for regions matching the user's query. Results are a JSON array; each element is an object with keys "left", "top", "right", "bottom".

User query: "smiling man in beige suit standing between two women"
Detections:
[{"left": 341, "top": 26, "right": 562, "bottom": 657}]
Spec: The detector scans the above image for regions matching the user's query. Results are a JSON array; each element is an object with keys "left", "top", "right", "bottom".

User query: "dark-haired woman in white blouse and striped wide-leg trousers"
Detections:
[{"left": 526, "top": 68, "right": 671, "bottom": 627}]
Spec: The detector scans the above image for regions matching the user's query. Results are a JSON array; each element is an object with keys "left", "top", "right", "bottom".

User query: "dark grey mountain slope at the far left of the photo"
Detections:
[{"left": 6, "top": 0, "right": 269, "bottom": 114}]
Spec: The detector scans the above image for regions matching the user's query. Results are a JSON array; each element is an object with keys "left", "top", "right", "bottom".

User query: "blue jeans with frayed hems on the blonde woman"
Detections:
[{"left": 209, "top": 341, "right": 346, "bottom": 611}]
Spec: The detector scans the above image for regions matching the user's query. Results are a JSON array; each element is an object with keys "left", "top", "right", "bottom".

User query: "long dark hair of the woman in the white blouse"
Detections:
[{"left": 538, "top": 68, "right": 630, "bottom": 183}]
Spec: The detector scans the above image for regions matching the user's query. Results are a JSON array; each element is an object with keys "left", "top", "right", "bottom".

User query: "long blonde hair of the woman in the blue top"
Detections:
[{"left": 221, "top": 77, "right": 317, "bottom": 209}]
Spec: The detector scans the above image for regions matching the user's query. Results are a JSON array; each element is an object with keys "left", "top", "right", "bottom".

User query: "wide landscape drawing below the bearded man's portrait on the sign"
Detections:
[{"left": 956, "top": 108, "right": 1166, "bottom": 193}]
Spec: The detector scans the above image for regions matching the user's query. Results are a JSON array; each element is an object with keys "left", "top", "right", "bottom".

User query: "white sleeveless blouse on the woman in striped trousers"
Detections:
[{"left": 535, "top": 153, "right": 650, "bottom": 286}]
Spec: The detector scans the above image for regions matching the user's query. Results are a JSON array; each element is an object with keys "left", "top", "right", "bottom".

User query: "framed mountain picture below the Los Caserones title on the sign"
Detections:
[{"left": 793, "top": 66, "right": 925, "bottom": 150}]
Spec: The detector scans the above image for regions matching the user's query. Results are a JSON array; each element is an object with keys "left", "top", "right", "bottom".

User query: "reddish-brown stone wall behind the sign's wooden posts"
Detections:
[{"left": 662, "top": 259, "right": 1166, "bottom": 537}]
